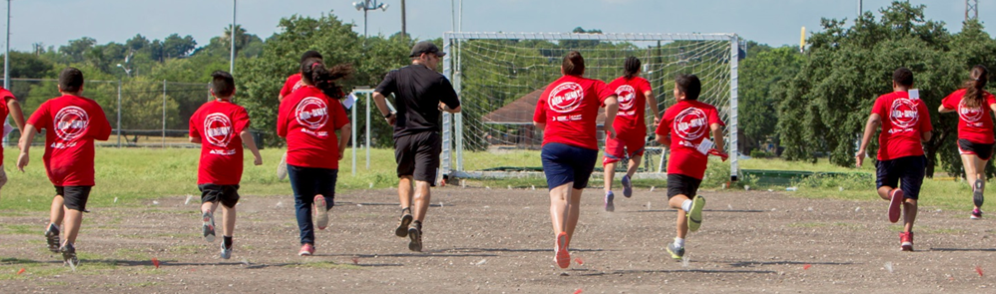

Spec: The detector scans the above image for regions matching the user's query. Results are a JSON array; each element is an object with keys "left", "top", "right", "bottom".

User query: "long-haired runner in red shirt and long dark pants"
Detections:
[{"left": 277, "top": 58, "right": 353, "bottom": 255}]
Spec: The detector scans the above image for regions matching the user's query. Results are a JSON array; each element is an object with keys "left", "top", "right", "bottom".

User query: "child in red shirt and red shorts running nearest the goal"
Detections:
[{"left": 602, "top": 56, "right": 658, "bottom": 211}]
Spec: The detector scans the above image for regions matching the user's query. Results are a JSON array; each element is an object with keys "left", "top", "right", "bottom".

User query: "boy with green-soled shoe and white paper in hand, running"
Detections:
[{"left": 655, "top": 74, "right": 727, "bottom": 260}]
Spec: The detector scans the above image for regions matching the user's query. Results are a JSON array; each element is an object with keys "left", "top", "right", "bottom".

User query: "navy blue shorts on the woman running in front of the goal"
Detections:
[{"left": 541, "top": 143, "right": 598, "bottom": 189}]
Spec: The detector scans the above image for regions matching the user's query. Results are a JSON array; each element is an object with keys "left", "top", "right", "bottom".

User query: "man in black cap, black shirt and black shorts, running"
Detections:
[{"left": 373, "top": 41, "right": 460, "bottom": 251}]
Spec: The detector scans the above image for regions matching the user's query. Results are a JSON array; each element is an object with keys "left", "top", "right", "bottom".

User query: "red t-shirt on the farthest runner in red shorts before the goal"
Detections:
[{"left": 609, "top": 77, "right": 652, "bottom": 138}]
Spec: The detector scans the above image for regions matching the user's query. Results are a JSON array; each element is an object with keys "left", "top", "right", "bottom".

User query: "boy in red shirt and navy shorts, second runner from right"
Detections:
[{"left": 855, "top": 67, "right": 933, "bottom": 251}]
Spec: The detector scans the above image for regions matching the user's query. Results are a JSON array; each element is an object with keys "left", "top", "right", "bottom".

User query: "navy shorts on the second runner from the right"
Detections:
[{"left": 875, "top": 155, "right": 927, "bottom": 200}]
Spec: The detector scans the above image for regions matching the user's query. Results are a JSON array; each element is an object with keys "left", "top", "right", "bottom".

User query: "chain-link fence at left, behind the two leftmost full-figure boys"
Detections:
[{"left": 0, "top": 78, "right": 217, "bottom": 147}]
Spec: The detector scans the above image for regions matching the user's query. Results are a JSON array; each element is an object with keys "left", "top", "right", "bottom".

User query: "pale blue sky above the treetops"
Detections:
[{"left": 0, "top": 0, "right": 996, "bottom": 51}]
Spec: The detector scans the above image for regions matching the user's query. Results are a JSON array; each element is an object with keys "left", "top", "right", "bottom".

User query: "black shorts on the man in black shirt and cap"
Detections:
[{"left": 394, "top": 131, "right": 443, "bottom": 187}]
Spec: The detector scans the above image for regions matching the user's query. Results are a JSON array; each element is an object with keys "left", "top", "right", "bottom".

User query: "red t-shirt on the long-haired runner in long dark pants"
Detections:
[{"left": 277, "top": 86, "right": 349, "bottom": 169}]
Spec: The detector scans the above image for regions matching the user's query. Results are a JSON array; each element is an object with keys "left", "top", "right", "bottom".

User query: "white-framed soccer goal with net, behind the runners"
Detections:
[{"left": 440, "top": 32, "right": 741, "bottom": 181}]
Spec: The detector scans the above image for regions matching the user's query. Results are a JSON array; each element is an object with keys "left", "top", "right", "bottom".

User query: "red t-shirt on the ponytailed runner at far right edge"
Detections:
[{"left": 941, "top": 89, "right": 996, "bottom": 144}]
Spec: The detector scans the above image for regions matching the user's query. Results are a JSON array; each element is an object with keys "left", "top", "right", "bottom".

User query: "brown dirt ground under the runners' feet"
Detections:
[{"left": 0, "top": 187, "right": 996, "bottom": 293}]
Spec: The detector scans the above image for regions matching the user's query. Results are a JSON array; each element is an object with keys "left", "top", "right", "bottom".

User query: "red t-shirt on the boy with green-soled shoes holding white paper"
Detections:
[{"left": 655, "top": 100, "right": 726, "bottom": 180}]
